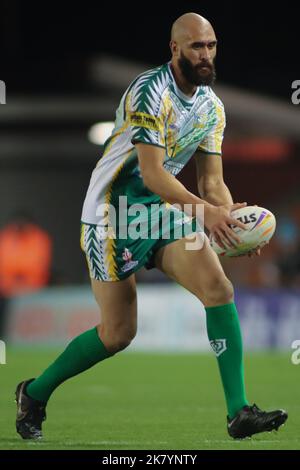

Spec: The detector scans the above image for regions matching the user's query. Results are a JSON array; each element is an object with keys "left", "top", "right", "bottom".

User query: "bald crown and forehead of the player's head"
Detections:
[{"left": 171, "top": 13, "right": 214, "bottom": 44}]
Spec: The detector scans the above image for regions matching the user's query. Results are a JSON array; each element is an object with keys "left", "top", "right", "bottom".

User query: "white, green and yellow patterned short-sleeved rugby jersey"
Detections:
[{"left": 81, "top": 64, "right": 225, "bottom": 224}]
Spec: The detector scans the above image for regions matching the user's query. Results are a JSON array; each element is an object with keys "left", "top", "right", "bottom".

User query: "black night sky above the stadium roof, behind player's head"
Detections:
[{"left": 0, "top": 0, "right": 299, "bottom": 99}]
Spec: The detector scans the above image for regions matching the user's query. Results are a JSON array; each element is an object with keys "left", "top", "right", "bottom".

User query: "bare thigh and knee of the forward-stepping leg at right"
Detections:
[{"left": 155, "top": 233, "right": 233, "bottom": 306}]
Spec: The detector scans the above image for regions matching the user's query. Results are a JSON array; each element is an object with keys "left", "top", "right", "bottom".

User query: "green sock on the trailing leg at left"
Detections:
[{"left": 26, "top": 328, "right": 113, "bottom": 402}]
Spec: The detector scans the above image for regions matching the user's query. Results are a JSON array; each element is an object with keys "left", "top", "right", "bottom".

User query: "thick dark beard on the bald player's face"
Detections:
[{"left": 178, "top": 52, "right": 216, "bottom": 86}]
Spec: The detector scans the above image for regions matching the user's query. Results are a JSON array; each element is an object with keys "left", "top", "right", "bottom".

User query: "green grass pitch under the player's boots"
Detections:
[{"left": 0, "top": 350, "right": 300, "bottom": 450}]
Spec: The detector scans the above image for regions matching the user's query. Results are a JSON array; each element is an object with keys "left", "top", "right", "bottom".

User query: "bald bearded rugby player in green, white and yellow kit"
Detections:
[{"left": 16, "top": 13, "right": 287, "bottom": 439}]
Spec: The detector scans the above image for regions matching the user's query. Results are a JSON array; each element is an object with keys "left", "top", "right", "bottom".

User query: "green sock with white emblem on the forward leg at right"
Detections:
[{"left": 205, "top": 303, "right": 248, "bottom": 418}]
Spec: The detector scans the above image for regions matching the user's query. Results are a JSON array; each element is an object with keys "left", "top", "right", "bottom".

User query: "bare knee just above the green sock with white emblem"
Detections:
[{"left": 203, "top": 275, "right": 234, "bottom": 307}]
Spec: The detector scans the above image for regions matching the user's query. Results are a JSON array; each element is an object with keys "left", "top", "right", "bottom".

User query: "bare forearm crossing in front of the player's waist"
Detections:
[{"left": 144, "top": 168, "right": 210, "bottom": 215}]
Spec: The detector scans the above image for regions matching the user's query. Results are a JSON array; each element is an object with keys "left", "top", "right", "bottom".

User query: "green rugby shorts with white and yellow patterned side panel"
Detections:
[{"left": 80, "top": 202, "right": 203, "bottom": 281}]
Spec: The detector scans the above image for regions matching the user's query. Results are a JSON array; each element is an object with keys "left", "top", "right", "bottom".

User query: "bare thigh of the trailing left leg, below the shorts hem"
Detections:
[{"left": 91, "top": 274, "right": 137, "bottom": 331}]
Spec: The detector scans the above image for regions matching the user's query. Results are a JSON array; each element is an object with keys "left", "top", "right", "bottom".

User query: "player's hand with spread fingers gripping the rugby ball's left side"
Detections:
[{"left": 204, "top": 202, "right": 247, "bottom": 249}]
